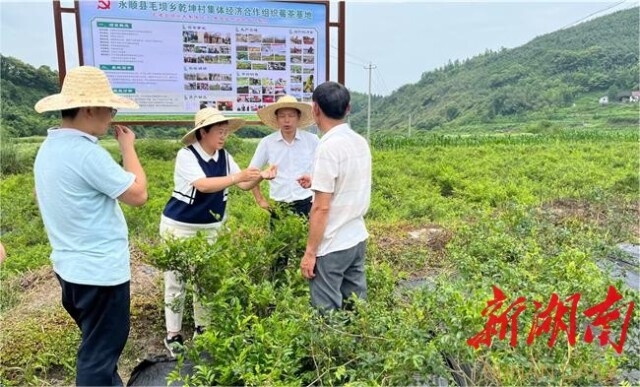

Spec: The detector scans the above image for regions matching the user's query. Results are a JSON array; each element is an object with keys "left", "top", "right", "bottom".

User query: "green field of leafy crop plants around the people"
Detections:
[{"left": 0, "top": 129, "right": 640, "bottom": 385}]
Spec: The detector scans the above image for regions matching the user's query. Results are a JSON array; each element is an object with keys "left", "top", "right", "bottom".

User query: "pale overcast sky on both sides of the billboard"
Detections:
[{"left": 0, "top": 0, "right": 640, "bottom": 95}]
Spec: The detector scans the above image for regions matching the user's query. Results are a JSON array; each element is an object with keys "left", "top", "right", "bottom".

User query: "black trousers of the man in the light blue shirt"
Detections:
[{"left": 56, "top": 274, "right": 130, "bottom": 386}]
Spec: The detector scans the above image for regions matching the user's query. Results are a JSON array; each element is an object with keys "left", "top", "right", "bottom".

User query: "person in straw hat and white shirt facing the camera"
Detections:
[{"left": 249, "top": 95, "right": 320, "bottom": 274}]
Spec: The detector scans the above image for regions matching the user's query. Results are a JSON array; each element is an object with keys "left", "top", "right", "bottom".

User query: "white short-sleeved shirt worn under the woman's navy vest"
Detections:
[{"left": 161, "top": 141, "right": 241, "bottom": 229}]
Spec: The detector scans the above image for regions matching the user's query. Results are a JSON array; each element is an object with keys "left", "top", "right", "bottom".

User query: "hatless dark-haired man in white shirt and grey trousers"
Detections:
[{"left": 300, "top": 82, "right": 371, "bottom": 311}]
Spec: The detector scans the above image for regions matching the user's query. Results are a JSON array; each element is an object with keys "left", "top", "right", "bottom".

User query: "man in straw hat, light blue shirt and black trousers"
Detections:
[{"left": 33, "top": 66, "right": 147, "bottom": 386}]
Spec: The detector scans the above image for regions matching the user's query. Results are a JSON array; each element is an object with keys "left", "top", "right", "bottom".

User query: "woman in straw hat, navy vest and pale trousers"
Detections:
[{"left": 160, "top": 107, "right": 276, "bottom": 356}]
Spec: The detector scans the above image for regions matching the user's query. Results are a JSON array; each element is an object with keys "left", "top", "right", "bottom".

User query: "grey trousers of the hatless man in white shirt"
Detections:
[{"left": 309, "top": 241, "right": 367, "bottom": 310}]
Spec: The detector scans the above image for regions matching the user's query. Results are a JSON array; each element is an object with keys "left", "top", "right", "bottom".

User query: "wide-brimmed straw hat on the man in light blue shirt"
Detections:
[{"left": 35, "top": 66, "right": 139, "bottom": 113}]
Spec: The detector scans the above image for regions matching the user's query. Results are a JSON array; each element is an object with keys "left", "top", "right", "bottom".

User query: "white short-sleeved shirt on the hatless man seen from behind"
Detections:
[{"left": 311, "top": 124, "right": 371, "bottom": 257}]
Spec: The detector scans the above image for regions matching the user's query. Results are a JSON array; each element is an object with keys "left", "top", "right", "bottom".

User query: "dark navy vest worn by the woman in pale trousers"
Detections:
[{"left": 163, "top": 145, "right": 229, "bottom": 224}]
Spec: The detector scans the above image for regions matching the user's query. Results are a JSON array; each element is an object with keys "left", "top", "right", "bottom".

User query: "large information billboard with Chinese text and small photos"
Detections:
[{"left": 78, "top": 0, "right": 329, "bottom": 116}]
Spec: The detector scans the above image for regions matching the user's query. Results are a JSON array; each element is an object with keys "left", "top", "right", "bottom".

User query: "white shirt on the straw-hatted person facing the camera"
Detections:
[{"left": 249, "top": 130, "right": 320, "bottom": 203}]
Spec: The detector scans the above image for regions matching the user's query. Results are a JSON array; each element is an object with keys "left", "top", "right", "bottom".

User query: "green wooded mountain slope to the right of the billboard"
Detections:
[{"left": 351, "top": 8, "right": 640, "bottom": 130}]
